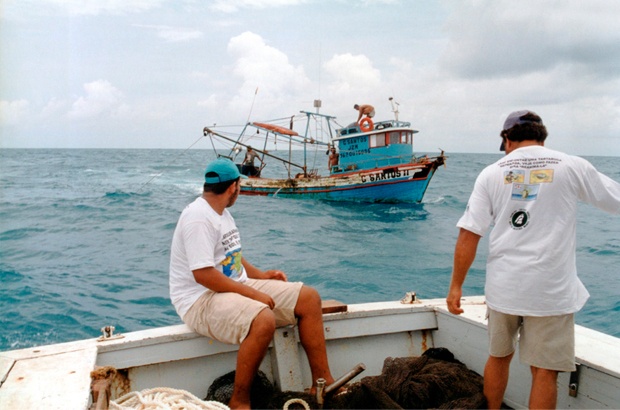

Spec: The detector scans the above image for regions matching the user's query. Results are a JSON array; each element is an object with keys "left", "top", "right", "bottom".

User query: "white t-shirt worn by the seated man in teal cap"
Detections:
[{"left": 170, "top": 197, "right": 247, "bottom": 318}]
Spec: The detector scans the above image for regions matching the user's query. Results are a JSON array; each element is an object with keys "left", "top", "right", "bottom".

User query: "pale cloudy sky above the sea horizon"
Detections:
[{"left": 0, "top": 0, "right": 620, "bottom": 156}]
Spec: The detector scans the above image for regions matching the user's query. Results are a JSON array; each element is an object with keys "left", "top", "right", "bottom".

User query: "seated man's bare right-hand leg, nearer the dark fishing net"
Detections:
[{"left": 295, "top": 286, "right": 334, "bottom": 392}]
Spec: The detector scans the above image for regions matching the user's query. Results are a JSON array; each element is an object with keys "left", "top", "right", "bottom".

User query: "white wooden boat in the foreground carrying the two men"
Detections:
[{"left": 0, "top": 292, "right": 620, "bottom": 409}]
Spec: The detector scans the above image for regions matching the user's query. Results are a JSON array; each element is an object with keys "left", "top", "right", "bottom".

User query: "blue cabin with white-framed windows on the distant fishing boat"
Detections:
[{"left": 331, "top": 120, "right": 418, "bottom": 174}]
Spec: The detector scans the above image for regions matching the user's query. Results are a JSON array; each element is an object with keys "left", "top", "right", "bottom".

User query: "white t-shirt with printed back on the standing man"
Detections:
[{"left": 457, "top": 145, "right": 620, "bottom": 316}]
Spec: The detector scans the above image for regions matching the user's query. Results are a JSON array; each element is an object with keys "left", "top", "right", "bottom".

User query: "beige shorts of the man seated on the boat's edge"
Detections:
[{"left": 183, "top": 279, "right": 303, "bottom": 344}]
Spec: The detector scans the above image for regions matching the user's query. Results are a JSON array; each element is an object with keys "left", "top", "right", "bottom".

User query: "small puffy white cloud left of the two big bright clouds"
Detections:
[{"left": 67, "top": 80, "right": 128, "bottom": 119}]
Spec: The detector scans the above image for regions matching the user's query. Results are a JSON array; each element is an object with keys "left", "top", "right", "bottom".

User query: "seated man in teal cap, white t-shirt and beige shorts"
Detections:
[{"left": 170, "top": 158, "right": 334, "bottom": 409}]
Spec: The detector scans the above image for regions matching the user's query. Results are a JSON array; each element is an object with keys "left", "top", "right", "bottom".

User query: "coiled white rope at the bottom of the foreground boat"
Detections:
[{"left": 110, "top": 387, "right": 230, "bottom": 410}]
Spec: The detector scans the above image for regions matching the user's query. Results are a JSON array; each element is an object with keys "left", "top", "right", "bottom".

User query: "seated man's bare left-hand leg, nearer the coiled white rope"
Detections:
[{"left": 228, "top": 309, "right": 276, "bottom": 409}]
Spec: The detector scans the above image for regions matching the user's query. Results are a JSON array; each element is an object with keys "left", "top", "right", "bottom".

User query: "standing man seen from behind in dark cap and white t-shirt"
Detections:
[{"left": 446, "top": 111, "right": 620, "bottom": 409}]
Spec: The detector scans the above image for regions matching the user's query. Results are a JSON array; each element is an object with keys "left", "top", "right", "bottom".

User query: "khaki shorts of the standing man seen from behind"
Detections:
[{"left": 487, "top": 309, "right": 575, "bottom": 372}]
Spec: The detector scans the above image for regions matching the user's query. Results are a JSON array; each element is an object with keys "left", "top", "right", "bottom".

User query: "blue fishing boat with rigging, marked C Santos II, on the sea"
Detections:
[{"left": 203, "top": 98, "right": 446, "bottom": 203}]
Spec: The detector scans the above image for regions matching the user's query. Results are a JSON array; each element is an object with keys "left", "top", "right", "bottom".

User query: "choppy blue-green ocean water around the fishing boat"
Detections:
[{"left": 0, "top": 149, "right": 620, "bottom": 351}]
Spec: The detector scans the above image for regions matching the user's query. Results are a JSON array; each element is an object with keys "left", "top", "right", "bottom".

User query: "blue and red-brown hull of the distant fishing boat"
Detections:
[{"left": 241, "top": 159, "right": 443, "bottom": 203}]
